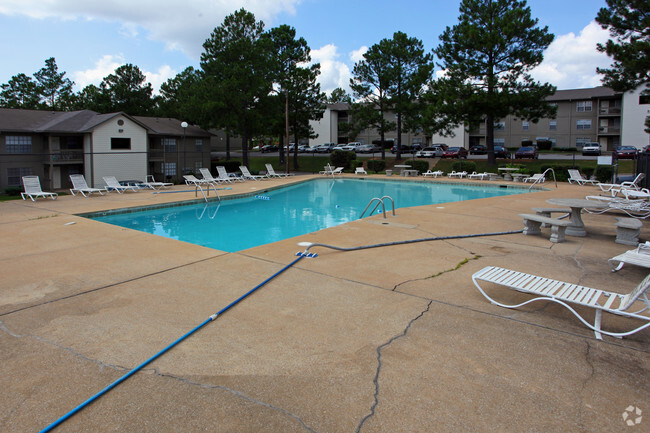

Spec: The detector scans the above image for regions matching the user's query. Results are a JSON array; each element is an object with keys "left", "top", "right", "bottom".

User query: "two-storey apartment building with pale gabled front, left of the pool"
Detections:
[{"left": 0, "top": 108, "right": 211, "bottom": 192}]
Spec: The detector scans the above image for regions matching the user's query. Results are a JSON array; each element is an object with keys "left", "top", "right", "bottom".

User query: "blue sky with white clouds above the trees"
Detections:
[{"left": 0, "top": 0, "right": 611, "bottom": 93}]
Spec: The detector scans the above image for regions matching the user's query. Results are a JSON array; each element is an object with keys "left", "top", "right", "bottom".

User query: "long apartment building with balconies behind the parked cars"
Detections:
[{"left": 311, "top": 87, "right": 650, "bottom": 150}]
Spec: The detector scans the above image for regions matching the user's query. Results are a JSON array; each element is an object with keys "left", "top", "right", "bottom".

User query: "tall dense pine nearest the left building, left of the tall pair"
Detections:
[{"left": 201, "top": 9, "right": 273, "bottom": 165}]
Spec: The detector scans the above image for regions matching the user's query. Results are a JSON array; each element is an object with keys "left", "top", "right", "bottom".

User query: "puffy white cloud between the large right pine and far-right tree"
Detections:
[{"left": 532, "top": 21, "right": 611, "bottom": 90}]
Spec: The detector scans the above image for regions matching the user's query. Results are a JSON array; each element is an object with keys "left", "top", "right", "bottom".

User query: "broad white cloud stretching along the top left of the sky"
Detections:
[{"left": 0, "top": 0, "right": 301, "bottom": 59}]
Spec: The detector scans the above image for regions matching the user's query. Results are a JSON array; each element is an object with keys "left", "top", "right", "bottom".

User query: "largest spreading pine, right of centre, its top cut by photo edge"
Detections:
[{"left": 428, "top": 0, "right": 555, "bottom": 165}]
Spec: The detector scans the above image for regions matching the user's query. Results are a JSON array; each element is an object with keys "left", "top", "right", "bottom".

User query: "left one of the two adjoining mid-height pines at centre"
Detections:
[{"left": 350, "top": 39, "right": 399, "bottom": 159}]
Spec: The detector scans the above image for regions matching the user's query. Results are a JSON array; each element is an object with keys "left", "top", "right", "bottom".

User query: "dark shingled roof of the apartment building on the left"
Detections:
[{"left": 0, "top": 108, "right": 211, "bottom": 137}]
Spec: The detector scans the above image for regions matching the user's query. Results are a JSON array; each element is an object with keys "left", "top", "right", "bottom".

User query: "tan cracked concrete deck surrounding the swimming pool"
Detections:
[{"left": 0, "top": 176, "right": 650, "bottom": 433}]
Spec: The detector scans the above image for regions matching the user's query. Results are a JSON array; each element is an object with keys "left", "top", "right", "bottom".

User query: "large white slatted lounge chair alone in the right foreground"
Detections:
[{"left": 472, "top": 266, "right": 650, "bottom": 340}]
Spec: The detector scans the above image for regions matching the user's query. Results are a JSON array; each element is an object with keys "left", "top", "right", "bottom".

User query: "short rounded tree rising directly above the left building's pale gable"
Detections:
[{"left": 100, "top": 63, "right": 154, "bottom": 116}]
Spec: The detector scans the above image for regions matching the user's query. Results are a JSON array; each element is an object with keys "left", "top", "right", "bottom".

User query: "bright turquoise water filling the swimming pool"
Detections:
[{"left": 93, "top": 179, "right": 527, "bottom": 252}]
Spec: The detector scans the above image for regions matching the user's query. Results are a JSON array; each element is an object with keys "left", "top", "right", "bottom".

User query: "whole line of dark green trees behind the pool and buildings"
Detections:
[{"left": 0, "top": 0, "right": 650, "bottom": 164}]
